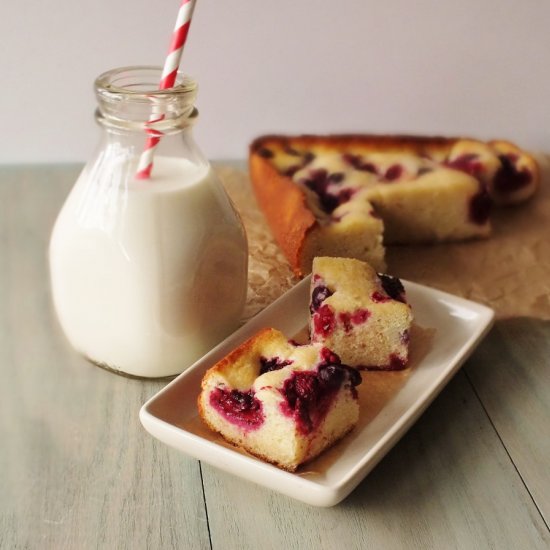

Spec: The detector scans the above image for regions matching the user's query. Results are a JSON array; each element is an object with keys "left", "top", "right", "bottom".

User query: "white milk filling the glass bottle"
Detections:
[{"left": 50, "top": 157, "right": 247, "bottom": 377}]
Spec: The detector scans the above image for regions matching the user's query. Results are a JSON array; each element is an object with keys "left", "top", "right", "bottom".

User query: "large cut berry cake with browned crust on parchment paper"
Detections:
[{"left": 250, "top": 135, "right": 539, "bottom": 276}]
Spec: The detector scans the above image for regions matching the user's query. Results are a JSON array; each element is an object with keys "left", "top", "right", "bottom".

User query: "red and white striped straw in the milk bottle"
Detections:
[{"left": 136, "top": 0, "right": 195, "bottom": 179}]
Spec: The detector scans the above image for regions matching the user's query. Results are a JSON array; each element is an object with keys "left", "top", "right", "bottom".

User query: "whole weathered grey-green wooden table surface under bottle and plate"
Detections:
[{"left": 0, "top": 165, "right": 550, "bottom": 550}]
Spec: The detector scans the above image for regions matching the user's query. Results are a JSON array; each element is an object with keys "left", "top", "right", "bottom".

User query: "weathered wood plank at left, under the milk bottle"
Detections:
[{"left": 0, "top": 167, "right": 210, "bottom": 549}]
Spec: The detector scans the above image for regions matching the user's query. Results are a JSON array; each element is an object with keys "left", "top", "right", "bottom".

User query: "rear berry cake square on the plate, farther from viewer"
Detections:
[{"left": 310, "top": 257, "right": 413, "bottom": 370}]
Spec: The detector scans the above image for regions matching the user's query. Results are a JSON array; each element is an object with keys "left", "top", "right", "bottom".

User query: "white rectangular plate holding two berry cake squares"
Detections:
[{"left": 140, "top": 278, "right": 494, "bottom": 506}]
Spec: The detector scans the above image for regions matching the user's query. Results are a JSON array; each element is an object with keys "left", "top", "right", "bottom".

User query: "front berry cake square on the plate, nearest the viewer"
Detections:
[{"left": 198, "top": 329, "right": 361, "bottom": 471}]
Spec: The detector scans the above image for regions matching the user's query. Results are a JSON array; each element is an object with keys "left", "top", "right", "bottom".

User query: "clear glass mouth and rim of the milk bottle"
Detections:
[{"left": 94, "top": 66, "right": 197, "bottom": 132}]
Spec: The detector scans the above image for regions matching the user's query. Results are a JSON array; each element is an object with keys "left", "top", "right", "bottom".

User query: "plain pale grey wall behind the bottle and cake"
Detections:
[{"left": 0, "top": 0, "right": 550, "bottom": 163}]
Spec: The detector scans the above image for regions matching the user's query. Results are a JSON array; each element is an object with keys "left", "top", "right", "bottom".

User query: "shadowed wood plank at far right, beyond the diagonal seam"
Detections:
[{"left": 467, "top": 319, "right": 550, "bottom": 525}]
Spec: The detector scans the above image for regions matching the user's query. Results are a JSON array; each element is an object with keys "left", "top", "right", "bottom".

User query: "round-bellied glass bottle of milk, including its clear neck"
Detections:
[{"left": 50, "top": 67, "right": 248, "bottom": 377}]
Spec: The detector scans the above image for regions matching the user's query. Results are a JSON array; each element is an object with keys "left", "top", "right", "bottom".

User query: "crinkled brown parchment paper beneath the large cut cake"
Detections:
[{"left": 216, "top": 155, "right": 550, "bottom": 320}]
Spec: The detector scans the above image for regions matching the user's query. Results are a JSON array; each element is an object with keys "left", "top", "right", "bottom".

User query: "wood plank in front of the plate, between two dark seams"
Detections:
[{"left": 203, "top": 372, "right": 550, "bottom": 550}]
